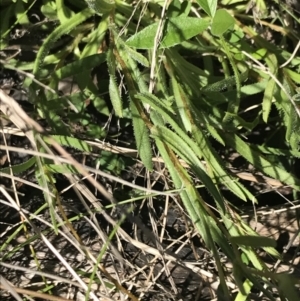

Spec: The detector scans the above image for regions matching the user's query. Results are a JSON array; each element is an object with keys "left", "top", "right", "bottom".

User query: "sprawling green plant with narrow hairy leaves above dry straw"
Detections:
[{"left": 1, "top": 0, "right": 300, "bottom": 300}]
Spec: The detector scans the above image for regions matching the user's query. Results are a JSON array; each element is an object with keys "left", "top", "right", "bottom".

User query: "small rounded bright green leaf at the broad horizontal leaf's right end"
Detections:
[{"left": 211, "top": 9, "right": 235, "bottom": 37}]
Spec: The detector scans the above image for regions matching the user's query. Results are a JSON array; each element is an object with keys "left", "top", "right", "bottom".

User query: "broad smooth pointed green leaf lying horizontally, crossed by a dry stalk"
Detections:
[{"left": 126, "top": 16, "right": 209, "bottom": 49}]
